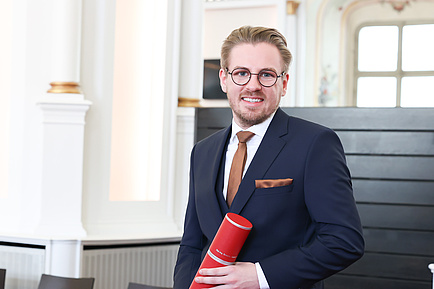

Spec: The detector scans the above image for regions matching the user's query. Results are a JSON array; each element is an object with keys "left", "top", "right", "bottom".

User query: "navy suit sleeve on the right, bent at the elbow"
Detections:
[{"left": 260, "top": 129, "right": 364, "bottom": 288}]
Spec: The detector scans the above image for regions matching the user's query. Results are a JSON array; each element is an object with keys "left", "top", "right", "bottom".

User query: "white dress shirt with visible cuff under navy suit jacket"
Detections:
[{"left": 223, "top": 113, "right": 274, "bottom": 289}]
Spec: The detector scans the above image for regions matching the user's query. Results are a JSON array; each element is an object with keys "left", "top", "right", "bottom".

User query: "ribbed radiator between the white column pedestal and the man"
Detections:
[{"left": 82, "top": 244, "right": 179, "bottom": 289}]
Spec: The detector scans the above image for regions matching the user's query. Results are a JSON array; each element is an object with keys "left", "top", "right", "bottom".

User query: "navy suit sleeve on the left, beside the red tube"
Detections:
[{"left": 173, "top": 148, "right": 203, "bottom": 289}]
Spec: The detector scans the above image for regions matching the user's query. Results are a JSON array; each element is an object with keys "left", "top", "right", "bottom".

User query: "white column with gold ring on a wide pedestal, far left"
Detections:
[{"left": 36, "top": 0, "right": 91, "bottom": 238}]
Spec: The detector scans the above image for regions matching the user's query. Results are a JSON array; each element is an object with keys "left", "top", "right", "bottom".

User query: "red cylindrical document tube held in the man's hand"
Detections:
[{"left": 190, "top": 213, "right": 253, "bottom": 289}]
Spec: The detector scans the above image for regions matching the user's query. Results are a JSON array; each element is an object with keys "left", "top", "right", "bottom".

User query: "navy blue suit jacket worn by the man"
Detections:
[{"left": 174, "top": 109, "right": 364, "bottom": 289}]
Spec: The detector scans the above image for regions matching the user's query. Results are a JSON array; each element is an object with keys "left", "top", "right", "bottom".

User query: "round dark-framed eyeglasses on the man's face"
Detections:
[{"left": 226, "top": 67, "right": 285, "bottom": 87}]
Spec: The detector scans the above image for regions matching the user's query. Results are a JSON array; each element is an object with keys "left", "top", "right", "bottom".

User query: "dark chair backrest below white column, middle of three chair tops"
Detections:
[{"left": 38, "top": 274, "right": 95, "bottom": 289}]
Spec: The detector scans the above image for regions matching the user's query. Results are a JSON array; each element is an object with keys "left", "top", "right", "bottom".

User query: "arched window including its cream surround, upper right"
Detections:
[{"left": 340, "top": 1, "right": 434, "bottom": 107}]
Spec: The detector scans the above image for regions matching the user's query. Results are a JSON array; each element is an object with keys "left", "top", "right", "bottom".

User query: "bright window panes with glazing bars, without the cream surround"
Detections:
[{"left": 354, "top": 22, "right": 434, "bottom": 107}]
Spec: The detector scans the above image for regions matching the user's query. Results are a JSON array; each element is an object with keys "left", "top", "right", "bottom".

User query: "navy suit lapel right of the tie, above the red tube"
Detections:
[{"left": 230, "top": 108, "right": 289, "bottom": 214}]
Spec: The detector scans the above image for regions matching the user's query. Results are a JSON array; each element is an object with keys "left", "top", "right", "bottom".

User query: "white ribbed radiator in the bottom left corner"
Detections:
[{"left": 0, "top": 245, "right": 45, "bottom": 289}]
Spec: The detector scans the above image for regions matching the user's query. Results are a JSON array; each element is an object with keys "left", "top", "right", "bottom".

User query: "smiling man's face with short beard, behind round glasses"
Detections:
[{"left": 219, "top": 43, "right": 289, "bottom": 129}]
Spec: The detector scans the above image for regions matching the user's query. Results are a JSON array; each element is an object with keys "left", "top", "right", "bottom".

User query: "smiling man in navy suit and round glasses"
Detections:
[{"left": 174, "top": 26, "right": 364, "bottom": 289}]
